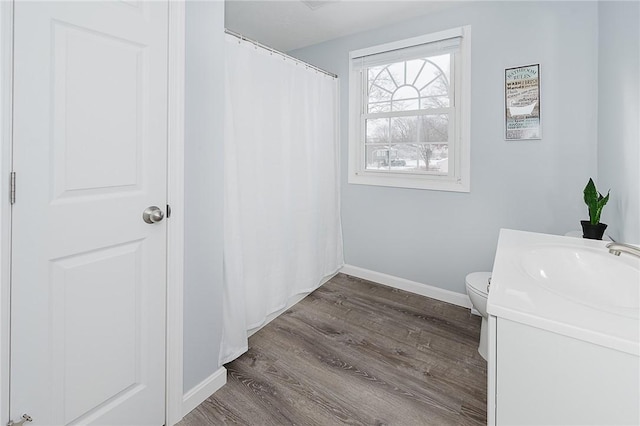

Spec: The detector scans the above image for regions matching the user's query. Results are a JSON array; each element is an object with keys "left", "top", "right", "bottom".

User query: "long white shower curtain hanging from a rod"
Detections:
[{"left": 220, "top": 35, "right": 344, "bottom": 364}]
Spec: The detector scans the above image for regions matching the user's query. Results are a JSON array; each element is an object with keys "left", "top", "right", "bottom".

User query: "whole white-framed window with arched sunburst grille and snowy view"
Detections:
[{"left": 349, "top": 27, "right": 470, "bottom": 192}]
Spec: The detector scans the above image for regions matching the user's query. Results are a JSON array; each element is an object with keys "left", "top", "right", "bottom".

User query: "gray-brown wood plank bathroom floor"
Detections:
[{"left": 179, "top": 274, "right": 487, "bottom": 426}]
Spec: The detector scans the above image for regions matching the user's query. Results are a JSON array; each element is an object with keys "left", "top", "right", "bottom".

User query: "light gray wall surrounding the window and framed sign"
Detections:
[{"left": 290, "top": 2, "right": 598, "bottom": 293}]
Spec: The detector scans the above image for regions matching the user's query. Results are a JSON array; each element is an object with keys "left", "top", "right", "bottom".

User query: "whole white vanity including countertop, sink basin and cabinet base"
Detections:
[{"left": 487, "top": 229, "right": 640, "bottom": 426}]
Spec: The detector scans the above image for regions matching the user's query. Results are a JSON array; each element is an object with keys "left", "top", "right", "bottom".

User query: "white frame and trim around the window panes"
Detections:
[{"left": 348, "top": 25, "right": 471, "bottom": 192}]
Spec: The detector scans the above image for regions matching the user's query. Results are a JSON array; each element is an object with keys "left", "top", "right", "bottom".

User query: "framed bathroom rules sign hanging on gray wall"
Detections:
[{"left": 504, "top": 64, "right": 542, "bottom": 141}]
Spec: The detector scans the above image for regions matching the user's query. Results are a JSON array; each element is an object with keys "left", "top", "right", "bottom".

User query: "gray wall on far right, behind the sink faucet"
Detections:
[{"left": 597, "top": 2, "right": 640, "bottom": 244}]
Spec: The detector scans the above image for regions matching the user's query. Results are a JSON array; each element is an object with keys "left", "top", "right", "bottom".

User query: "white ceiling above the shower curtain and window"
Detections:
[{"left": 225, "top": 0, "right": 456, "bottom": 52}]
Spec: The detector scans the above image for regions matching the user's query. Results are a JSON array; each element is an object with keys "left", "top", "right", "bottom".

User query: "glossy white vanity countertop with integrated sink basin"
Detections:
[{"left": 487, "top": 229, "right": 640, "bottom": 355}]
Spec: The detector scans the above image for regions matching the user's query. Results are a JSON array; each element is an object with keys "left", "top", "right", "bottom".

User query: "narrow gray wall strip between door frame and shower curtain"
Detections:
[{"left": 184, "top": 1, "right": 224, "bottom": 391}]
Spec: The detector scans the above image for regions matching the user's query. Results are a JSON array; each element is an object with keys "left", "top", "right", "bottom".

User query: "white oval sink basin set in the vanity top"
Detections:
[{"left": 521, "top": 244, "right": 640, "bottom": 318}]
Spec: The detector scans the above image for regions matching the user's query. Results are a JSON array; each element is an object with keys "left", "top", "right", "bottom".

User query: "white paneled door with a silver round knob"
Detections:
[{"left": 10, "top": 1, "right": 168, "bottom": 426}]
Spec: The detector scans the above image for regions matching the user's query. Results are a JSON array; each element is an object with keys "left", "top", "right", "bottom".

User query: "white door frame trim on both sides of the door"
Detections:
[{"left": 0, "top": 0, "right": 185, "bottom": 426}]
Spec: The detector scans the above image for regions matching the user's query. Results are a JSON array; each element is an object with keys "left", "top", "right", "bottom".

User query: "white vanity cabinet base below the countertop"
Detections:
[{"left": 489, "top": 317, "right": 640, "bottom": 426}]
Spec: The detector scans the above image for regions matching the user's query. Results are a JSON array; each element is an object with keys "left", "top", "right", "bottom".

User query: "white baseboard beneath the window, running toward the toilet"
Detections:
[{"left": 340, "top": 265, "right": 471, "bottom": 308}]
